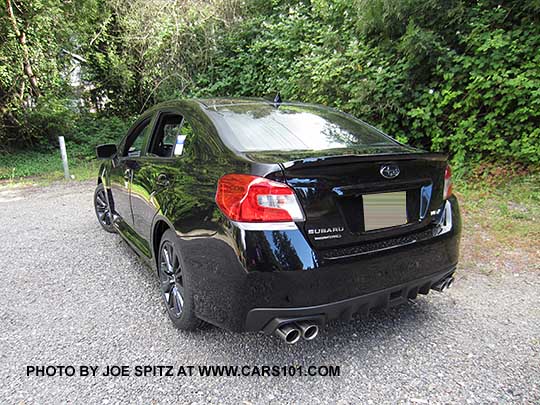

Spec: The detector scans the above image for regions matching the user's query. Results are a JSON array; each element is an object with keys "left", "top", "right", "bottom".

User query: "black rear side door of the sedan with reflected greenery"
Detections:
[{"left": 131, "top": 109, "right": 219, "bottom": 242}]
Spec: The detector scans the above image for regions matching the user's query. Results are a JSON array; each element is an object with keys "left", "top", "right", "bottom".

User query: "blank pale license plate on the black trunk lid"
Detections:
[{"left": 362, "top": 191, "right": 407, "bottom": 231}]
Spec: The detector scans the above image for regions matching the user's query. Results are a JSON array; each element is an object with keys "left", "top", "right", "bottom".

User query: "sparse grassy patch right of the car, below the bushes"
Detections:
[{"left": 454, "top": 165, "right": 540, "bottom": 275}]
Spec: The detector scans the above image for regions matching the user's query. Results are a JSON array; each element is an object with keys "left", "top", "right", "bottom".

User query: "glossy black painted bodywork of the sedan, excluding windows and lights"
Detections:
[{"left": 98, "top": 99, "right": 461, "bottom": 331}]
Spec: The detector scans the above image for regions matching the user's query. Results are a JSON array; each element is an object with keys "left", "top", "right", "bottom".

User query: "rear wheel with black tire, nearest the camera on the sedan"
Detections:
[{"left": 157, "top": 229, "right": 205, "bottom": 330}]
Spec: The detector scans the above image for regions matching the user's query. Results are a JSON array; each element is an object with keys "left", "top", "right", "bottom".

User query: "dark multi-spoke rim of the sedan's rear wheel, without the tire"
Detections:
[{"left": 159, "top": 241, "right": 184, "bottom": 318}]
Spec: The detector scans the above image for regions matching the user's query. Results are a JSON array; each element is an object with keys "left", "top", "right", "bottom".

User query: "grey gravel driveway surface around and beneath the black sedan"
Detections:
[{"left": 0, "top": 182, "right": 540, "bottom": 404}]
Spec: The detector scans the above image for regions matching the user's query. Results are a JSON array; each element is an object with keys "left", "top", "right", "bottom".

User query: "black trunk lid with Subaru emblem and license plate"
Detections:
[{"left": 274, "top": 150, "right": 446, "bottom": 248}]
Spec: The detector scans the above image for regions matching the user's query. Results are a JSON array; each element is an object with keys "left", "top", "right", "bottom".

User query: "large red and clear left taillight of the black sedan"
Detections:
[{"left": 216, "top": 174, "right": 304, "bottom": 222}]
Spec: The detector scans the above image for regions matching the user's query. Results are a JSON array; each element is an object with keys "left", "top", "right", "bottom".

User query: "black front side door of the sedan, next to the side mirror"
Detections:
[{"left": 110, "top": 114, "right": 152, "bottom": 228}]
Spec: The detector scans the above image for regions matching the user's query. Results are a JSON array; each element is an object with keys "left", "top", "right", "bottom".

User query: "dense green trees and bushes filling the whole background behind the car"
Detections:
[{"left": 0, "top": 0, "right": 540, "bottom": 165}]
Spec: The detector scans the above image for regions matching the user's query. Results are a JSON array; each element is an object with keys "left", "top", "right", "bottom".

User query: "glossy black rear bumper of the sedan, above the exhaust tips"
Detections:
[{"left": 178, "top": 198, "right": 461, "bottom": 331}]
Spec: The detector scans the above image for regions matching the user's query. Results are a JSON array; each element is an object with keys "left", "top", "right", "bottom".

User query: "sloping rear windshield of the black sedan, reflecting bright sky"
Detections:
[{"left": 208, "top": 104, "right": 397, "bottom": 152}]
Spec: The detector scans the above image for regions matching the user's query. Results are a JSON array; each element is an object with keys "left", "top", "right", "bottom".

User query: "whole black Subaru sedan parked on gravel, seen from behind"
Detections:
[{"left": 95, "top": 99, "right": 461, "bottom": 343}]
